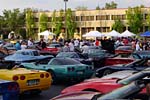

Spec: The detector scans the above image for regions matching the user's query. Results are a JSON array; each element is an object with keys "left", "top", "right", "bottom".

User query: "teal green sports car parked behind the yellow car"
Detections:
[{"left": 20, "top": 58, "right": 94, "bottom": 81}]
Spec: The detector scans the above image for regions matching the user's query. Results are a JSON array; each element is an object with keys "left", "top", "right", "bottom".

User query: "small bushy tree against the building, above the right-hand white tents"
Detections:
[{"left": 112, "top": 19, "right": 125, "bottom": 33}]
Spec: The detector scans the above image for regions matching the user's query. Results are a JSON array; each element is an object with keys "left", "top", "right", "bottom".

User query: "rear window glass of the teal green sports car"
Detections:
[{"left": 50, "top": 58, "right": 81, "bottom": 65}]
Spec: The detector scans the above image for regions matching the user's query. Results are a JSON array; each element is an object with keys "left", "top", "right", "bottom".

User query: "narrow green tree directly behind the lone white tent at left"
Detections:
[{"left": 39, "top": 13, "right": 48, "bottom": 31}]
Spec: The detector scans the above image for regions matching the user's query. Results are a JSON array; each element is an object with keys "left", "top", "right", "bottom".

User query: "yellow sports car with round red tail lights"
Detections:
[{"left": 0, "top": 62, "right": 52, "bottom": 93}]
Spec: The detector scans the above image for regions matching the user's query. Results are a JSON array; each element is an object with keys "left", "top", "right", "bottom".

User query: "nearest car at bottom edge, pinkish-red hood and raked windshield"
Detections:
[{"left": 50, "top": 80, "right": 148, "bottom": 100}]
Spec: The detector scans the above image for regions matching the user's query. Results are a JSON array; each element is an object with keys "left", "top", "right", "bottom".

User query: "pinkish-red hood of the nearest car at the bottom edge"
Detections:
[{"left": 51, "top": 91, "right": 99, "bottom": 100}]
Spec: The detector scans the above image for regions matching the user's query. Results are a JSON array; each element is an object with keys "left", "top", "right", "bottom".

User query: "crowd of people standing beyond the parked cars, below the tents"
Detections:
[{"left": 1, "top": 37, "right": 150, "bottom": 54}]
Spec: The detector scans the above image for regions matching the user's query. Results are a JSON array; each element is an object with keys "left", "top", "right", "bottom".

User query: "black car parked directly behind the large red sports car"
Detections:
[{"left": 95, "top": 59, "right": 150, "bottom": 77}]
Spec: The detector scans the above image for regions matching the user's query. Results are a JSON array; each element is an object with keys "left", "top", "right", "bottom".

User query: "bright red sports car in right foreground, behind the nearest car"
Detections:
[{"left": 61, "top": 69, "right": 150, "bottom": 94}]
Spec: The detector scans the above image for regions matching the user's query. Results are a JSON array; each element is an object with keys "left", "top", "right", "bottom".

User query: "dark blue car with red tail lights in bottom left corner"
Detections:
[{"left": 0, "top": 80, "right": 19, "bottom": 100}]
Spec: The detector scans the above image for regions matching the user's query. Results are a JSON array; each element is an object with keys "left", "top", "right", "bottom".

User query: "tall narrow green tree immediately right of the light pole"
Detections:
[{"left": 66, "top": 9, "right": 77, "bottom": 38}]
